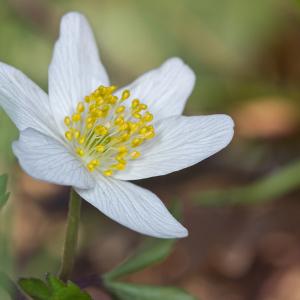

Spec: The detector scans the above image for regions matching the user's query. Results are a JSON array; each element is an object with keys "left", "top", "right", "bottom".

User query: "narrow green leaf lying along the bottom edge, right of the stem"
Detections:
[{"left": 106, "top": 282, "right": 195, "bottom": 300}]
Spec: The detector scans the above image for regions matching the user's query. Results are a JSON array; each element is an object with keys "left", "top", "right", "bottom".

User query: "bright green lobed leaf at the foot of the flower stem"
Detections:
[{"left": 19, "top": 275, "right": 92, "bottom": 300}]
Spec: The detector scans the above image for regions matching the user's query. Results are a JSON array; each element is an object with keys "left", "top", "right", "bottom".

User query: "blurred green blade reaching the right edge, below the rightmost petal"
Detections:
[{"left": 195, "top": 160, "right": 300, "bottom": 205}]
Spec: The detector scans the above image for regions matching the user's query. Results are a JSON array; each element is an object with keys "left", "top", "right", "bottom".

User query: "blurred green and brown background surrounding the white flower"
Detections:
[{"left": 0, "top": 0, "right": 300, "bottom": 300}]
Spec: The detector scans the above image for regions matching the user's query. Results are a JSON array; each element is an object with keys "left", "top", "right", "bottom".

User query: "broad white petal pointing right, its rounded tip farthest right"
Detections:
[{"left": 115, "top": 115, "right": 233, "bottom": 180}]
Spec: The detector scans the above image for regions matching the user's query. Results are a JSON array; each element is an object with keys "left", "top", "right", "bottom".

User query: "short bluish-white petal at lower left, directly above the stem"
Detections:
[{"left": 13, "top": 128, "right": 94, "bottom": 188}]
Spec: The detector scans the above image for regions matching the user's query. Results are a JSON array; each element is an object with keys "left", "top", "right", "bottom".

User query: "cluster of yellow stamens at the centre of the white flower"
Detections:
[{"left": 64, "top": 86, "right": 155, "bottom": 176}]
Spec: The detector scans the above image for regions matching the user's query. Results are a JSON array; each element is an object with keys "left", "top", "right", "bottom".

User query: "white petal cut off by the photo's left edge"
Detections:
[{"left": 0, "top": 63, "right": 52, "bottom": 134}]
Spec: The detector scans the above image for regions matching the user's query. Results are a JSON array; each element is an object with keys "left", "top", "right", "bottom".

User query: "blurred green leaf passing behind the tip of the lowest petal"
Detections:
[{"left": 104, "top": 200, "right": 181, "bottom": 280}]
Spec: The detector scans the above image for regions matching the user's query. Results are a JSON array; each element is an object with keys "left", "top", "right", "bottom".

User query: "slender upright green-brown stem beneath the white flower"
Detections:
[{"left": 59, "top": 189, "right": 81, "bottom": 281}]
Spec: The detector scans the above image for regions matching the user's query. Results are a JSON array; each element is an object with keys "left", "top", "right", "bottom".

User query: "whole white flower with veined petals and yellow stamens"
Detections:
[{"left": 0, "top": 13, "right": 233, "bottom": 238}]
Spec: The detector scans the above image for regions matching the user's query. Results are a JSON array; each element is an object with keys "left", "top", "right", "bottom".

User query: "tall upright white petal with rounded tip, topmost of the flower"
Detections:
[{"left": 49, "top": 13, "right": 109, "bottom": 134}]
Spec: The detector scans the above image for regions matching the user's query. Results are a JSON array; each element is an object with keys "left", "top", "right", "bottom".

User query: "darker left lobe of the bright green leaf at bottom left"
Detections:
[{"left": 19, "top": 278, "right": 51, "bottom": 300}]
